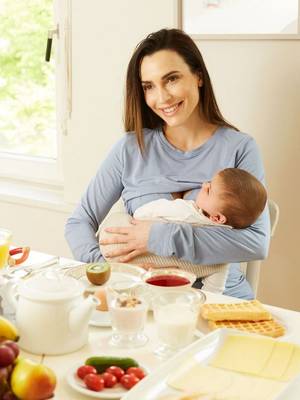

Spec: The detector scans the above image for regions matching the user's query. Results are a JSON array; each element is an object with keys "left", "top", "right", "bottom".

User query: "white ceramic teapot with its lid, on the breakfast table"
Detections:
[{"left": 9, "top": 271, "right": 99, "bottom": 354}]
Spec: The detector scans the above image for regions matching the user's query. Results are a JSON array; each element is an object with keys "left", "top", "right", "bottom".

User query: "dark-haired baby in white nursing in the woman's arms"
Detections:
[{"left": 133, "top": 168, "right": 267, "bottom": 229}]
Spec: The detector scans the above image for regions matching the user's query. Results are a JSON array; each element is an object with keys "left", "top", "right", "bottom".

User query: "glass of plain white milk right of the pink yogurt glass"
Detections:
[{"left": 152, "top": 288, "right": 205, "bottom": 358}]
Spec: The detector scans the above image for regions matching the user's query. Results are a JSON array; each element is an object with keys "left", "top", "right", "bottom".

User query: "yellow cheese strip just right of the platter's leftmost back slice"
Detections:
[{"left": 259, "top": 342, "right": 295, "bottom": 380}]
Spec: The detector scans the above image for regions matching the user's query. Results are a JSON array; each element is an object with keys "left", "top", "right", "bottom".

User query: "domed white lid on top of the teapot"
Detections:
[{"left": 18, "top": 270, "right": 84, "bottom": 301}]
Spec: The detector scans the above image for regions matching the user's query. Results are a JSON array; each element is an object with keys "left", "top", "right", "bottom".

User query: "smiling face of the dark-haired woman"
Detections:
[{"left": 141, "top": 50, "right": 202, "bottom": 127}]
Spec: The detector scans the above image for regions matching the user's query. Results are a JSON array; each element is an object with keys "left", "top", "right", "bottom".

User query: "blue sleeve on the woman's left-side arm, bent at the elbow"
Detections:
[{"left": 65, "top": 141, "right": 123, "bottom": 262}]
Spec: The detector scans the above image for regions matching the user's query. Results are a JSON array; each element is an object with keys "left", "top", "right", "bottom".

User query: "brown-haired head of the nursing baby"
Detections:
[{"left": 196, "top": 168, "right": 267, "bottom": 229}]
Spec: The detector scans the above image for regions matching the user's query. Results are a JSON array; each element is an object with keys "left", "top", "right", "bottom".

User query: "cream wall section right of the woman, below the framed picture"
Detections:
[{"left": 199, "top": 40, "right": 300, "bottom": 310}]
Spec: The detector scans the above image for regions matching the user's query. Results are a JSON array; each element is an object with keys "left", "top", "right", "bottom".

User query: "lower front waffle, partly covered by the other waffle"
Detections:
[{"left": 208, "top": 319, "right": 285, "bottom": 338}]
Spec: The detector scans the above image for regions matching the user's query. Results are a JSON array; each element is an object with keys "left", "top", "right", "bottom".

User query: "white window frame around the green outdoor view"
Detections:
[{"left": 0, "top": 0, "right": 71, "bottom": 185}]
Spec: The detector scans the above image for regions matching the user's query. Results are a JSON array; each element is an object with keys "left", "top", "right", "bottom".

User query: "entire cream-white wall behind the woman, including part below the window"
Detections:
[{"left": 0, "top": 0, "right": 300, "bottom": 310}]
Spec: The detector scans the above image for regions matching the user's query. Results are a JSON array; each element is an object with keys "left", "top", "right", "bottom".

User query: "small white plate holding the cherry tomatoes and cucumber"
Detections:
[{"left": 66, "top": 364, "right": 147, "bottom": 399}]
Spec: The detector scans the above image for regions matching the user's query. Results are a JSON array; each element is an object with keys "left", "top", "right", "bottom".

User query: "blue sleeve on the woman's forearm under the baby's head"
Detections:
[{"left": 148, "top": 209, "right": 270, "bottom": 264}]
